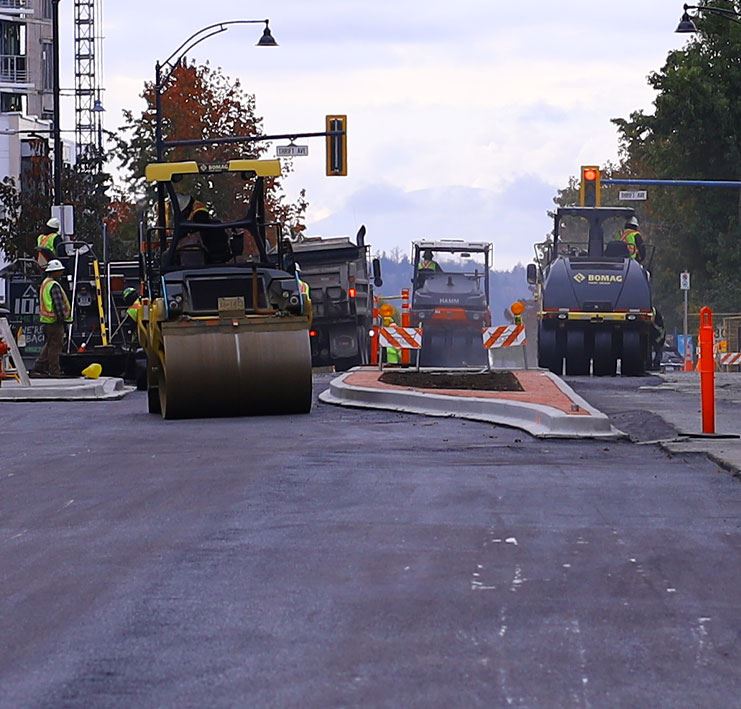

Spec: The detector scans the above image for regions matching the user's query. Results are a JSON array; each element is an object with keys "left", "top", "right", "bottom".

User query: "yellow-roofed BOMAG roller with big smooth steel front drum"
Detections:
[{"left": 138, "top": 159, "right": 312, "bottom": 419}]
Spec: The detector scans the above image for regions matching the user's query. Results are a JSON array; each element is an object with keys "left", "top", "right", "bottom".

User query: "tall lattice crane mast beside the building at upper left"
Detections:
[{"left": 74, "top": 0, "right": 103, "bottom": 171}]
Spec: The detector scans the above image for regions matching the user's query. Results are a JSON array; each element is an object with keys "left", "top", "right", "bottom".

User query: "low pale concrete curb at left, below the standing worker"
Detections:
[{"left": 0, "top": 377, "right": 136, "bottom": 402}]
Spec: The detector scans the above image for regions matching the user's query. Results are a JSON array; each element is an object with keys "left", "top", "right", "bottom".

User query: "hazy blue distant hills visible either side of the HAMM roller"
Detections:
[{"left": 375, "top": 254, "right": 532, "bottom": 324}]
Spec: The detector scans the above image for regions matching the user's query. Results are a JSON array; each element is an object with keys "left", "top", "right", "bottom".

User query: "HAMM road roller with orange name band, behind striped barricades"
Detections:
[{"left": 411, "top": 239, "right": 493, "bottom": 367}]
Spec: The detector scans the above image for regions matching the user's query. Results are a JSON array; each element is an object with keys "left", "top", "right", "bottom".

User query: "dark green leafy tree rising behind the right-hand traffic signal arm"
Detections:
[{"left": 614, "top": 1, "right": 741, "bottom": 315}]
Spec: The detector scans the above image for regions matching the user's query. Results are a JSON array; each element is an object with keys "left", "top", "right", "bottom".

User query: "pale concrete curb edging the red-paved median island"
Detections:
[{"left": 319, "top": 370, "right": 625, "bottom": 439}]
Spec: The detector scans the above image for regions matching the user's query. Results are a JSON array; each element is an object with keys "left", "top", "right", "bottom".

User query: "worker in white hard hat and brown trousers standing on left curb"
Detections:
[{"left": 31, "top": 259, "right": 72, "bottom": 377}]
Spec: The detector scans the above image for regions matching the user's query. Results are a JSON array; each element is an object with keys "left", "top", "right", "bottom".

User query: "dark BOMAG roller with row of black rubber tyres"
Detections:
[{"left": 527, "top": 207, "right": 654, "bottom": 376}]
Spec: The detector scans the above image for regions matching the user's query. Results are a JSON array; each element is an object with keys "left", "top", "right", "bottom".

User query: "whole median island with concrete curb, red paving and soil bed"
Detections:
[{"left": 319, "top": 367, "right": 623, "bottom": 438}]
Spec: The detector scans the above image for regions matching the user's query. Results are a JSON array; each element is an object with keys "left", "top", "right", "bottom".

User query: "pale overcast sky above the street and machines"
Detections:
[{"left": 61, "top": 0, "right": 683, "bottom": 268}]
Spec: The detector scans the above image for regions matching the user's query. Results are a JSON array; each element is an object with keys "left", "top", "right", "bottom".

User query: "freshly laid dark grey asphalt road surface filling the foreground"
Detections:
[{"left": 0, "top": 375, "right": 741, "bottom": 707}]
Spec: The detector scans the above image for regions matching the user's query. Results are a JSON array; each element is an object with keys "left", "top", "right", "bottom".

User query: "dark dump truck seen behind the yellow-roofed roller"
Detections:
[{"left": 293, "top": 226, "right": 383, "bottom": 371}]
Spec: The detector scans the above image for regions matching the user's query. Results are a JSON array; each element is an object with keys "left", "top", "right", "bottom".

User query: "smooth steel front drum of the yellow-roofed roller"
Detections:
[{"left": 159, "top": 325, "right": 311, "bottom": 419}]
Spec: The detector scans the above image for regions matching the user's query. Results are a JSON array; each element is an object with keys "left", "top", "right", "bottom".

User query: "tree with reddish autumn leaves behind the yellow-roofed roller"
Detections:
[{"left": 109, "top": 61, "right": 307, "bottom": 253}]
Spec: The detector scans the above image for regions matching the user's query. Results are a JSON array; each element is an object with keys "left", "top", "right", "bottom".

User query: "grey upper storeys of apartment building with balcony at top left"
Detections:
[{"left": 0, "top": 0, "right": 54, "bottom": 119}]
